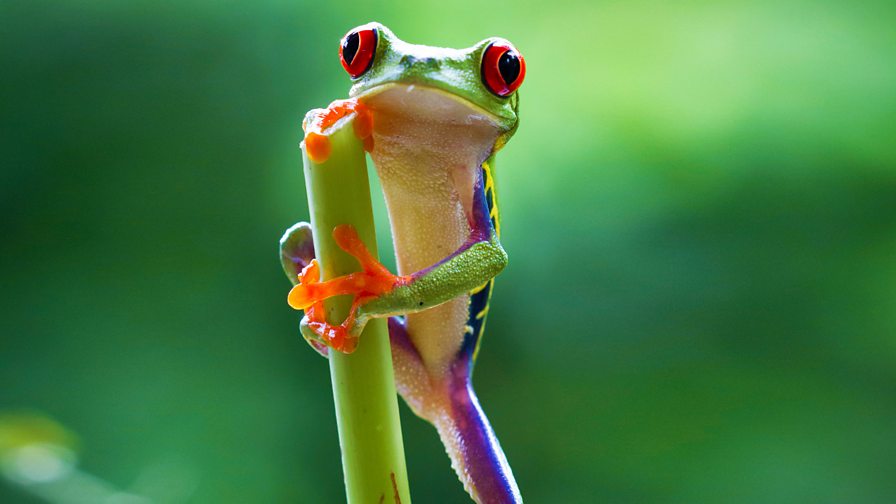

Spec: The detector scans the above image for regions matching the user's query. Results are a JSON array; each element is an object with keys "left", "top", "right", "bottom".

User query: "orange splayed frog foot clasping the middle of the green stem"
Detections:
[{"left": 287, "top": 224, "right": 408, "bottom": 353}]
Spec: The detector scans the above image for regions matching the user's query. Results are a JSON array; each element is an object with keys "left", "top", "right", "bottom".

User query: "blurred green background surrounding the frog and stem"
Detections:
[{"left": 0, "top": 0, "right": 896, "bottom": 504}]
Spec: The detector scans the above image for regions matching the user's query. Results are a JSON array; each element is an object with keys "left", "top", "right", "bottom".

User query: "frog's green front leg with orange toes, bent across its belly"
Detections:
[{"left": 288, "top": 168, "right": 507, "bottom": 352}]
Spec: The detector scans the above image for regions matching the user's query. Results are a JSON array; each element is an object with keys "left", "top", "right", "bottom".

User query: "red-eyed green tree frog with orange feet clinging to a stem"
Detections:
[{"left": 280, "top": 22, "right": 526, "bottom": 504}]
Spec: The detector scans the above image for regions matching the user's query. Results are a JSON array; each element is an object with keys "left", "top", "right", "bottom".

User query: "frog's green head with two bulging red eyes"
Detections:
[{"left": 339, "top": 23, "right": 526, "bottom": 149}]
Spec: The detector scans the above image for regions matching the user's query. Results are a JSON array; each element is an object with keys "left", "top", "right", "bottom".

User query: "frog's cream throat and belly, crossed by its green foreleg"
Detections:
[{"left": 365, "top": 85, "right": 498, "bottom": 373}]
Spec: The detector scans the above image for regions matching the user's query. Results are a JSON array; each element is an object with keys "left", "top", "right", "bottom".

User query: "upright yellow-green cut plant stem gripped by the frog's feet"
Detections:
[{"left": 302, "top": 114, "right": 411, "bottom": 504}]
